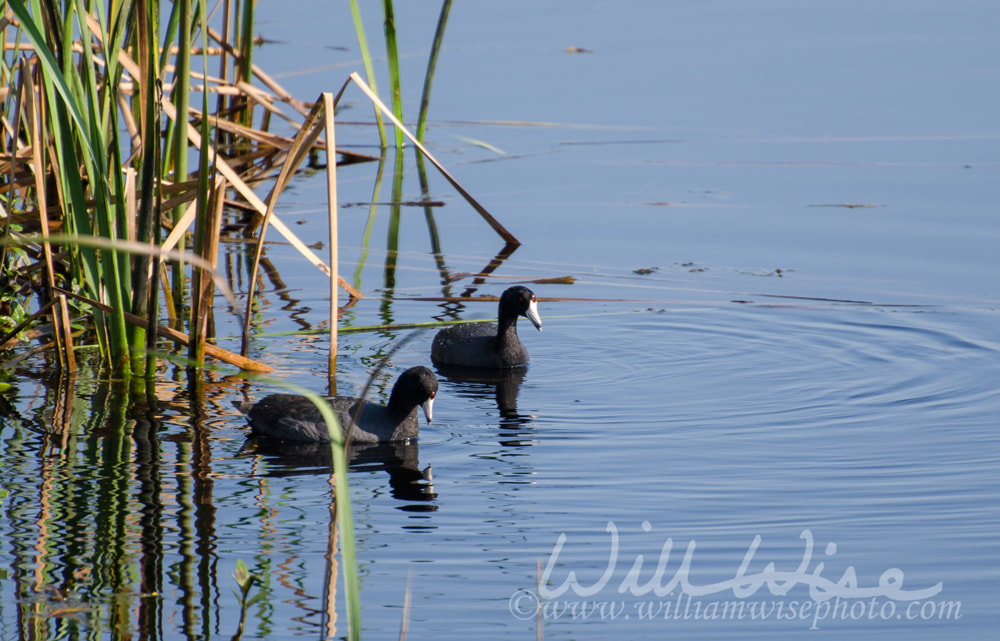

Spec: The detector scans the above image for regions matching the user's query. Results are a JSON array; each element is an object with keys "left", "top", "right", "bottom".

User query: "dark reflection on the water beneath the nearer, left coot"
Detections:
[{"left": 239, "top": 436, "right": 437, "bottom": 504}]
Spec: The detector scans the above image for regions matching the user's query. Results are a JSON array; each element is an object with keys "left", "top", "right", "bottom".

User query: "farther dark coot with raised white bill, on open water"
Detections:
[{"left": 431, "top": 286, "right": 542, "bottom": 369}]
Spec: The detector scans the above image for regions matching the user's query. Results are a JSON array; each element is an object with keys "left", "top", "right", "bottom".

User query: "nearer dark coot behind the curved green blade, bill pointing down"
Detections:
[{"left": 236, "top": 367, "right": 437, "bottom": 443}]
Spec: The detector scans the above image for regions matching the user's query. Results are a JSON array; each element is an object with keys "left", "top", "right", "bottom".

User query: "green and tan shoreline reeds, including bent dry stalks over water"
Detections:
[{"left": 0, "top": 0, "right": 519, "bottom": 638}]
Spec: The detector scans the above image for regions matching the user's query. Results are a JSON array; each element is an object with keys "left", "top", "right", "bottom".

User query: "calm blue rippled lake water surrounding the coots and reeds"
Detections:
[{"left": 0, "top": 0, "right": 1000, "bottom": 641}]
